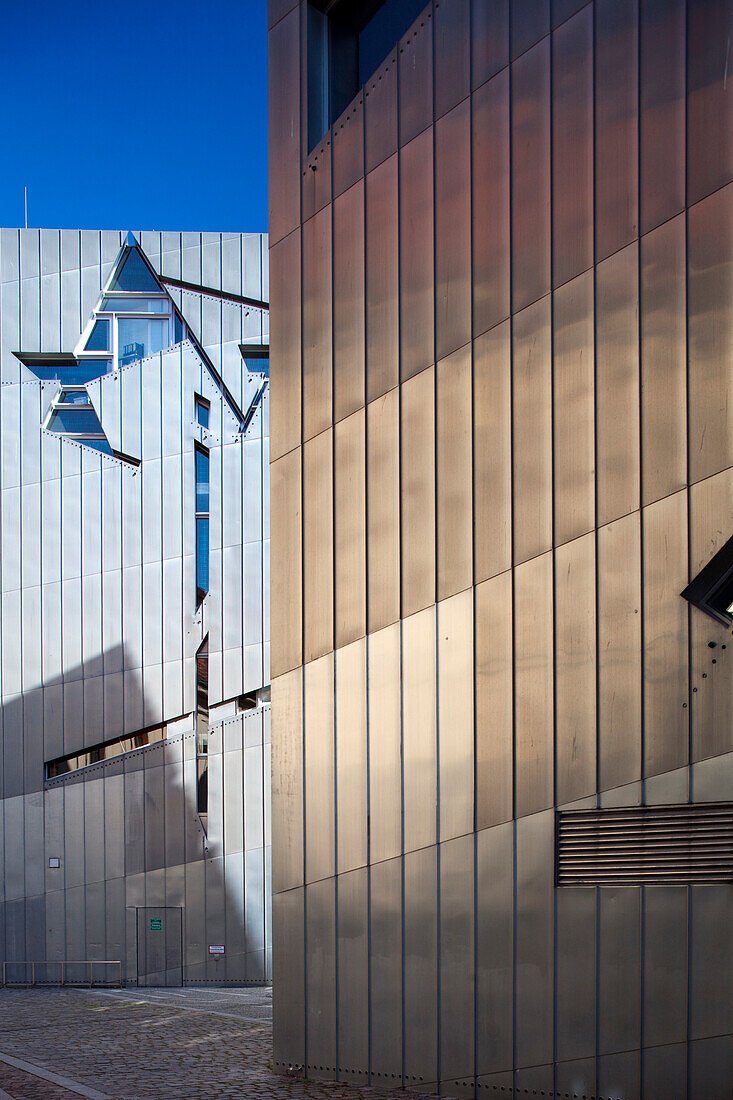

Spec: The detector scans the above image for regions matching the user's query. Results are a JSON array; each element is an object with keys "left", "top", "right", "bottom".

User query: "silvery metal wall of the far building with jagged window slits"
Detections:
[{"left": 0, "top": 230, "right": 270, "bottom": 982}]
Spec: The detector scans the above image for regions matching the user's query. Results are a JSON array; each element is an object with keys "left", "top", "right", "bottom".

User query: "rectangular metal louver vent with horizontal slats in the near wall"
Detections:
[{"left": 556, "top": 802, "right": 733, "bottom": 887}]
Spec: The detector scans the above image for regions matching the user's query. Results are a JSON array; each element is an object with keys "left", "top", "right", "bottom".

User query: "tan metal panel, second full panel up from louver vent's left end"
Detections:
[{"left": 553, "top": 271, "right": 595, "bottom": 545}]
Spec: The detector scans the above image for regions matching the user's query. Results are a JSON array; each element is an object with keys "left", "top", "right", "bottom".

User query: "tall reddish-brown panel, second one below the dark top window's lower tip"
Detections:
[{"left": 303, "top": 210, "right": 332, "bottom": 439}]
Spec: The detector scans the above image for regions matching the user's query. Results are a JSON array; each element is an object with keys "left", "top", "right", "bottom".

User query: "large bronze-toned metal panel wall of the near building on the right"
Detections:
[{"left": 270, "top": 0, "right": 733, "bottom": 1100}]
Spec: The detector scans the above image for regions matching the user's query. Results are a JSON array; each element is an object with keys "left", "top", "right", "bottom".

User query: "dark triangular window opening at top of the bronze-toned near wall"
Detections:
[{"left": 307, "top": 0, "right": 426, "bottom": 152}]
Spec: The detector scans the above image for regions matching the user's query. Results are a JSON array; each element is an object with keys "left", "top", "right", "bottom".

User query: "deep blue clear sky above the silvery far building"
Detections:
[{"left": 0, "top": 0, "right": 267, "bottom": 232}]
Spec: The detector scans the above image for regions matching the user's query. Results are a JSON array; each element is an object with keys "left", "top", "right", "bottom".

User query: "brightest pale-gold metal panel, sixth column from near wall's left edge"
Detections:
[{"left": 437, "top": 591, "right": 474, "bottom": 840}]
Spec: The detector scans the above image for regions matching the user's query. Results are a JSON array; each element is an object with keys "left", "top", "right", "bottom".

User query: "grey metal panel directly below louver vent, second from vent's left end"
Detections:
[{"left": 598, "top": 887, "right": 642, "bottom": 1054}]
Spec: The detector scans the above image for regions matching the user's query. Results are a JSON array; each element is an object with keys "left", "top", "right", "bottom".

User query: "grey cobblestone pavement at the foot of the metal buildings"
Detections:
[{"left": 0, "top": 988, "right": 435, "bottom": 1100}]
